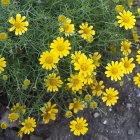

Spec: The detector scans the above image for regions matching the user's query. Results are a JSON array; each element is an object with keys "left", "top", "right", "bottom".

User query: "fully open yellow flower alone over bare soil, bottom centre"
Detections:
[{"left": 69, "top": 117, "right": 88, "bottom": 136}]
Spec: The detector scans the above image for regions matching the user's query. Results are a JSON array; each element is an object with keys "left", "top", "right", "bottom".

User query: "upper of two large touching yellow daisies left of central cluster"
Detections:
[{"left": 50, "top": 37, "right": 71, "bottom": 58}]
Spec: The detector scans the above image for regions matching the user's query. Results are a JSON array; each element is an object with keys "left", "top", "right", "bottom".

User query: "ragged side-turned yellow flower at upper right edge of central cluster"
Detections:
[{"left": 89, "top": 52, "right": 102, "bottom": 67}]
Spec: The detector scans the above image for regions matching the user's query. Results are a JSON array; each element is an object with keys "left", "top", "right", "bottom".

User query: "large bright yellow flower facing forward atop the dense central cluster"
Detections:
[{"left": 74, "top": 55, "right": 95, "bottom": 77}]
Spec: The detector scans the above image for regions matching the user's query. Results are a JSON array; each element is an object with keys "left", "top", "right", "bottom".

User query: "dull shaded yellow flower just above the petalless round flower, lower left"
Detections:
[{"left": 11, "top": 103, "right": 26, "bottom": 114}]
